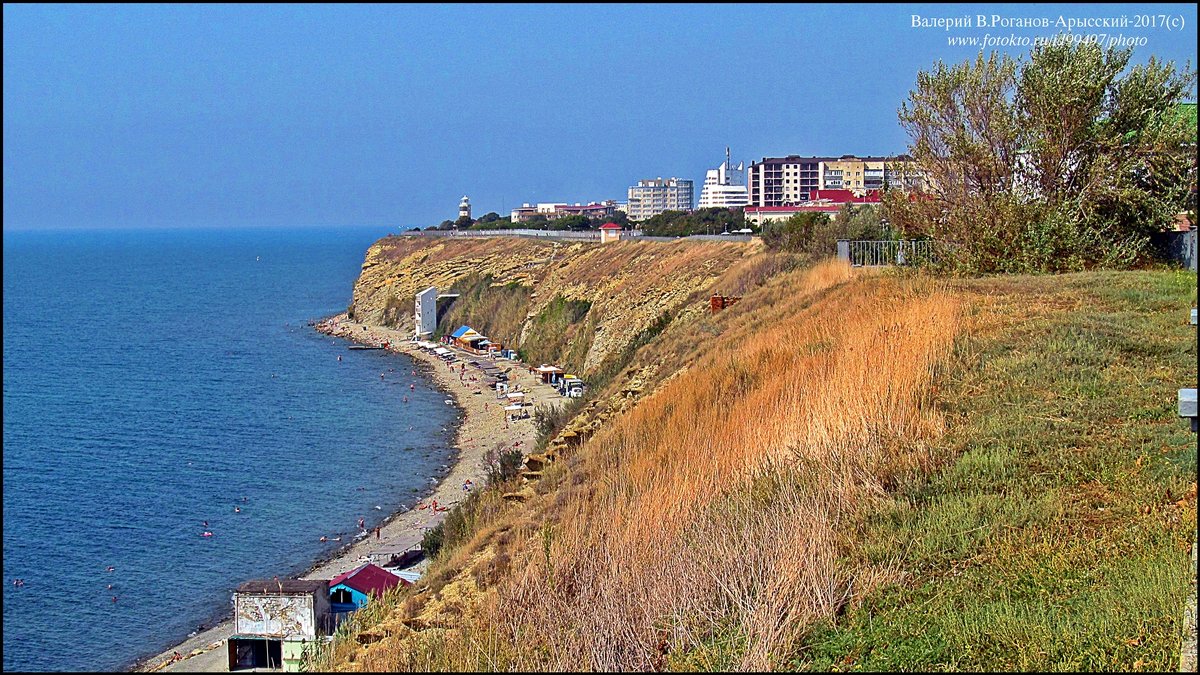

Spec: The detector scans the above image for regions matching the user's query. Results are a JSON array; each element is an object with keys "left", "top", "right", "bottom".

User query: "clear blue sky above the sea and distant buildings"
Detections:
[{"left": 4, "top": 4, "right": 1196, "bottom": 229}]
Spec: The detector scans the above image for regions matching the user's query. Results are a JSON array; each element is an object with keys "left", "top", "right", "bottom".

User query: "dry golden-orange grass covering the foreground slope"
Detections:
[{"left": 336, "top": 257, "right": 960, "bottom": 670}]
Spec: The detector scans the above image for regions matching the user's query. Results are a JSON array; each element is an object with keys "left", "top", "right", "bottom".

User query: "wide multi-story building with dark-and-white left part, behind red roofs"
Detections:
[{"left": 748, "top": 155, "right": 924, "bottom": 207}]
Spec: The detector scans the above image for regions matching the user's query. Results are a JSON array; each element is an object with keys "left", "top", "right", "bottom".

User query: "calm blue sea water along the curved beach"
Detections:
[{"left": 4, "top": 228, "right": 457, "bottom": 670}]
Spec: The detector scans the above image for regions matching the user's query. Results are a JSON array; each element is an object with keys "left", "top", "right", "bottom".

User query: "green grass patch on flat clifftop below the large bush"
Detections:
[{"left": 785, "top": 271, "right": 1196, "bottom": 671}]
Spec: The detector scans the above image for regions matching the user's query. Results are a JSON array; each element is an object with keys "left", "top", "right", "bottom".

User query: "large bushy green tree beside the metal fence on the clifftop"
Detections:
[{"left": 884, "top": 40, "right": 1195, "bottom": 271}]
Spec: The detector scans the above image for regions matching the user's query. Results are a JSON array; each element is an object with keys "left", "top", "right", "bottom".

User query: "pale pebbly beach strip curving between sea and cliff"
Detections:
[{"left": 135, "top": 312, "right": 559, "bottom": 673}]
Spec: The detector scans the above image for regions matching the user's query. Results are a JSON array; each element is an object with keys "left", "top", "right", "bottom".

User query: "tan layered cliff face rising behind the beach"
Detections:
[{"left": 352, "top": 237, "right": 758, "bottom": 375}]
